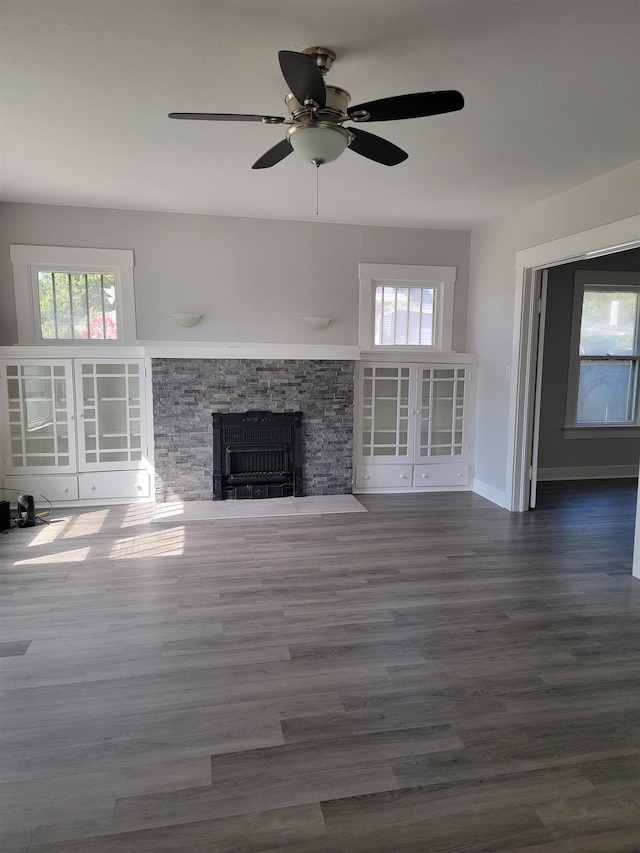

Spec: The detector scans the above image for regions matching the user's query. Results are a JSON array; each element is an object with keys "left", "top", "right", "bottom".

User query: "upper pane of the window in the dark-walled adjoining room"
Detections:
[{"left": 580, "top": 290, "right": 638, "bottom": 355}]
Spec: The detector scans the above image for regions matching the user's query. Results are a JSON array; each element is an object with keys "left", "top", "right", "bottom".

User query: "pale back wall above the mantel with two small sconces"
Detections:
[{"left": 0, "top": 203, "right": 470, "bottom": 351}]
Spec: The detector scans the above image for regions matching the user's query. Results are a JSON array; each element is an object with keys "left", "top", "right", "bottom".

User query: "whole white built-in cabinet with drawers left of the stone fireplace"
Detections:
[{"left": 0, "top": 358, "right": 151, "bottom": 502}]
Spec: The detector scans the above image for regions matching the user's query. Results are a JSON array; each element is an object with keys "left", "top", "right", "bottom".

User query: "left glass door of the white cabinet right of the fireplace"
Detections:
[{"left": 360, "top": 365, "right": 413, "bottom": 461}]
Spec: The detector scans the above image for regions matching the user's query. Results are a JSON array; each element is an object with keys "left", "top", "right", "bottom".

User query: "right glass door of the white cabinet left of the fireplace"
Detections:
[{"left": 76, "top": 361, "right": 143, "bottom": 471}]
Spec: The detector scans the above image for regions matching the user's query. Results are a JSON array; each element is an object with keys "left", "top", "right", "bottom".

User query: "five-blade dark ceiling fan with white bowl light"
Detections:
[{"left": 169, "top": 47, "right": 464, "bottom": 169}]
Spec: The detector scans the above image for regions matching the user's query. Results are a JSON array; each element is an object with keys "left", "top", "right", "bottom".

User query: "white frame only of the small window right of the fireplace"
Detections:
[{"left": 358, "top": 264, "right": 456, "bottom": 355}]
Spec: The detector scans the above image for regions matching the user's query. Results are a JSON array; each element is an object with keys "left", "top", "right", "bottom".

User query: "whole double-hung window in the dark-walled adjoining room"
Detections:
[{"left": 567, "top": 271, "right": 640, "bottom": 429}]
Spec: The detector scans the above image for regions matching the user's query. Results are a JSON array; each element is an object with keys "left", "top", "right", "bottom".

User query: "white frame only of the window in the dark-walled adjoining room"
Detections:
[{"left": 564, "top": 270, "right": 640, "bottom": 439}]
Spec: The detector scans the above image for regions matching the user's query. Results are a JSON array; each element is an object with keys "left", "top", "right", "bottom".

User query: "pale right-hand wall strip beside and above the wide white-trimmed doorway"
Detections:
[{"left": 467, "top": 162, "right": 640, "bottom": 506}]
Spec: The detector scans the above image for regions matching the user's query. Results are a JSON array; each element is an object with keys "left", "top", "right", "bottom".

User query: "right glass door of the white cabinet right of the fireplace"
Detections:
[{"left": 417, "top": 366, "right": 467, "bottom": 459}]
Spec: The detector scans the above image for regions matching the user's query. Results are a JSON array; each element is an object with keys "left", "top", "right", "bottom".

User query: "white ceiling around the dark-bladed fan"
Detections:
[{"left": 0, "top": 0, "right": 640, "bottom": 228}]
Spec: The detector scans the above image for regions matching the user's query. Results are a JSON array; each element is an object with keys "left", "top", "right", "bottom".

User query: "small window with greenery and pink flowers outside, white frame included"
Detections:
[{"left": 11, "top": 246, "right": 136, "bottom": 345}]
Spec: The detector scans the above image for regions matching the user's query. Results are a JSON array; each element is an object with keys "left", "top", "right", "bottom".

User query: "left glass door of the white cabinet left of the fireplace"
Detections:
[{"left": 3, "top": 361, "right": 76, "bottom": 474}]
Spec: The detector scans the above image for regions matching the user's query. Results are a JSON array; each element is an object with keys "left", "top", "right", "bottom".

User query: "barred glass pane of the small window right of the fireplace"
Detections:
[{"left": 374, "top": 285, "right": 435, "bottom": 346}]
